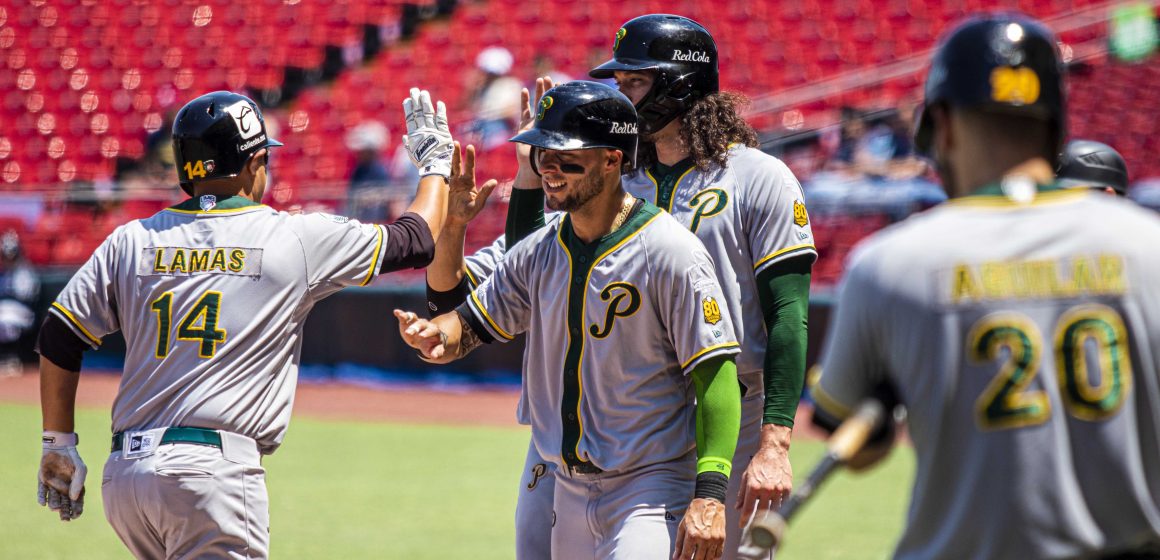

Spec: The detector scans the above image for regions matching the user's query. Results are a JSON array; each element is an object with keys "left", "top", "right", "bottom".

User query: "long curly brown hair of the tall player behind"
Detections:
[{"left": 637, "top": 92, "right": 757, "bottom": 170}]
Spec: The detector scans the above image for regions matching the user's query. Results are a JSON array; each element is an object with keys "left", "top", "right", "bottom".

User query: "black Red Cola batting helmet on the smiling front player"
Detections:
[{"left": 510, "top": 81, "right": 638, "bottom": 173}]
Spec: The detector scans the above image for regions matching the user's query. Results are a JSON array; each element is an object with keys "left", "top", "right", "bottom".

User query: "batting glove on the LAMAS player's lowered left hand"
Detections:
[{"left": 36, "top": 430, "right": 88, "bottom": 521}]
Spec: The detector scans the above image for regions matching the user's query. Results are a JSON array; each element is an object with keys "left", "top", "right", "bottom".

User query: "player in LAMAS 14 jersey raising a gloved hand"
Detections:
[{"left": 38, "top": 89, "right": 479, "bottom": 559}]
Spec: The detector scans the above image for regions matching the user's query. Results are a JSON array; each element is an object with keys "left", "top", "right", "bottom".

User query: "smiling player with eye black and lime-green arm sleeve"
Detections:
[{"left": 396, "top": 81, "right": 740, "bottom": 560}]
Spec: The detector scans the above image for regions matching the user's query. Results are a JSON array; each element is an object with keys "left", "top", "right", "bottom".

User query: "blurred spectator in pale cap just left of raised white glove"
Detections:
[{"left": 345, "top": 121, "right": 391, "bottom": 223}]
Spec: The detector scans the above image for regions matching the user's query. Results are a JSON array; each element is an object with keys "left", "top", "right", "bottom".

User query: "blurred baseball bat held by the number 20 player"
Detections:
[{"left": 749, "top": 399, "right": 886, "bottom": 552}]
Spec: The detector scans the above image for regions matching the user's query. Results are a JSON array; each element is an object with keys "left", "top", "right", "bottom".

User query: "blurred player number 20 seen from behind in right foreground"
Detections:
[{"left": 813, "top": 14, "right": 1160, "bottom": 559}]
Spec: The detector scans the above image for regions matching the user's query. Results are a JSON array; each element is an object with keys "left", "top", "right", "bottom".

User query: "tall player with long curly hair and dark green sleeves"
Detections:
[{"left": 508, "top": 14, "right": 817, "bottom": 558}]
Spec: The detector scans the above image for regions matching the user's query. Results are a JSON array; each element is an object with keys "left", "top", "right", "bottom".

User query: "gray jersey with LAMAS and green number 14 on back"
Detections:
[{"left": 51, "top": 197, "right": 386, "bottom": 453}]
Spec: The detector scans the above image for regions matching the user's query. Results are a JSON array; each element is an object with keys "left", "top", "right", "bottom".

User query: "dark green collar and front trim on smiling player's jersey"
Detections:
[{"left": 556, "top": 198, "right": 660, "bottom": 466}]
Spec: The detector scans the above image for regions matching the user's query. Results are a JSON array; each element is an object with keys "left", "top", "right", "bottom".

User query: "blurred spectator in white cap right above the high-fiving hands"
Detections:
[{"left": 467, "top": 46, "right": 523, "bottom": 150}]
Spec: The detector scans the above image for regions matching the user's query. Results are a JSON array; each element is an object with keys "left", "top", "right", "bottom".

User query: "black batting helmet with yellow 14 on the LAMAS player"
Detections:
[{"left": 173, "top": 92, "right": 282, "bottom": 196}]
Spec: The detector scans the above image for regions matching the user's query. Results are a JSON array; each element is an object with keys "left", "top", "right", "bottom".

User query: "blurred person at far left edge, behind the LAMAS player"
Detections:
[{"left": 0, "top": 230, "right": 41, "bottom": 377}]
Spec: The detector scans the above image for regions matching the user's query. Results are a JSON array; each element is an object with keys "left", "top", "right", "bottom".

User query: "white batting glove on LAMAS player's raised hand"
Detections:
[{"left": 403, "top": 87, "right": 452, "bottom": 179}]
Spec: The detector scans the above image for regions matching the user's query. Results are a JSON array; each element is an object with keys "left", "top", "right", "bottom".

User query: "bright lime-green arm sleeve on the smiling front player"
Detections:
[{"left": 689, "top": 356, "right": 741, "bottom": 477}]
